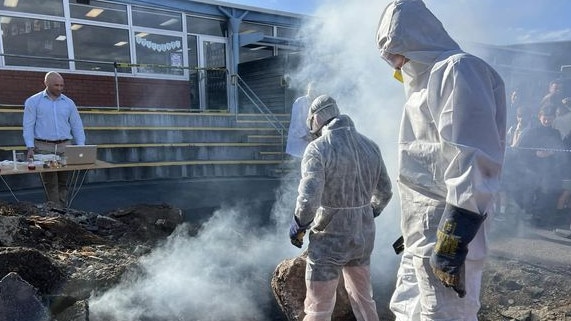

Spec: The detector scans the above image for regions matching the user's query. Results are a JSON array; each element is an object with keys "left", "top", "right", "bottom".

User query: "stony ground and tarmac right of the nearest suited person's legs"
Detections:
[{"left": 479, "top": 219, "right": 571, "bottom": 321}]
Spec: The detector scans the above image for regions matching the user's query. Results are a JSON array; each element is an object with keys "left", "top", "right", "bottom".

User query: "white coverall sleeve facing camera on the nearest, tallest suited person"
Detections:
[{"left": 428, "top": 55, "right": 506, "bottom": 214}]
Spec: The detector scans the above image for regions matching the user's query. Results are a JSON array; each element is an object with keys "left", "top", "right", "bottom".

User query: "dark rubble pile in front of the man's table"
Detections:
[{"left": 0, "top": 202, "right": 190, "bottom": 321}]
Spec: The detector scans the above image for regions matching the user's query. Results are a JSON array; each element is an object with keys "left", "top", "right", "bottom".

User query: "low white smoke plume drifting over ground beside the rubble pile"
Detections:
[{"left": 90, "top": 191, "right": 299, "bottom": 321}]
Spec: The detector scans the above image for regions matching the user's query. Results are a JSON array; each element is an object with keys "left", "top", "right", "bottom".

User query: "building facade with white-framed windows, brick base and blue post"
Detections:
[{"left": 0, "top": 0, "right": 308, "bottom": 112}]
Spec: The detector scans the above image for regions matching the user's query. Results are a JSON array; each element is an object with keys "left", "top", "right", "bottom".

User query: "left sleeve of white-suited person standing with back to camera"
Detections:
[{"left": 295, "top": 144, "right": 325, "bottom": 226}]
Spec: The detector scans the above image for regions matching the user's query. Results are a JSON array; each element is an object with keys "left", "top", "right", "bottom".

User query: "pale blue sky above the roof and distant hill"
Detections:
[{"left": 224, "top": 0, "right": 571, "bottom": 45}]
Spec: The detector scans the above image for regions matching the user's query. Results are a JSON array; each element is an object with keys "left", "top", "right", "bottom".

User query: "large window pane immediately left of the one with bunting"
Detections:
[{"left": 73, "top": 25, "right": 131, "bottom": 71}]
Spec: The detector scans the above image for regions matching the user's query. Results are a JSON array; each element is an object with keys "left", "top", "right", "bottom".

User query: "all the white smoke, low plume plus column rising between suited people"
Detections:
[{"left": 90, "top": 0, "right": 404, "bottom": 321}]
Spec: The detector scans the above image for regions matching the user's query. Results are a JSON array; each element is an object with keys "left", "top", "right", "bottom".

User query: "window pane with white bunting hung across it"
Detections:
[{"left": 135, "top": 33, "right": 184, "bottom": 75}]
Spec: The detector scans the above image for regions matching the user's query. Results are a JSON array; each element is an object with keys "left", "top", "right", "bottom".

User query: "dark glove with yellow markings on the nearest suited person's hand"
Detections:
[{"left": 430, "top": 204, "right": 486, "bottom": 298}]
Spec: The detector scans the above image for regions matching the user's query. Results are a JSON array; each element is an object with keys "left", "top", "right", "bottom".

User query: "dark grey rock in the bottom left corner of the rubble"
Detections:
[{"left": 0, "top": 272, "right": 50, "bottom": 321}]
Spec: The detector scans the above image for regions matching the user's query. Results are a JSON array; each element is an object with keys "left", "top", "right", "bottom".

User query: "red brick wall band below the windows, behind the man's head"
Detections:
[{"left": 0, "top": 70, "right": 190, "bottom": 109}]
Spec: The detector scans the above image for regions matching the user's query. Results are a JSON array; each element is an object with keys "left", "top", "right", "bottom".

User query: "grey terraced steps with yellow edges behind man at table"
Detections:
[{"left": 0, "top": 106, "right": 289, "bottom": 191}]
